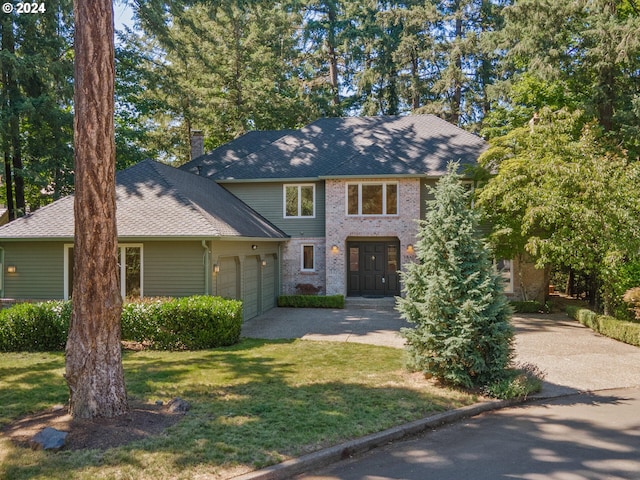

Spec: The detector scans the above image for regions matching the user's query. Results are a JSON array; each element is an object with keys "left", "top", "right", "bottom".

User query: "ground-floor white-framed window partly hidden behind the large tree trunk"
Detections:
[{"left": 64, "top": 244, "right": 143, "bottom": 299}]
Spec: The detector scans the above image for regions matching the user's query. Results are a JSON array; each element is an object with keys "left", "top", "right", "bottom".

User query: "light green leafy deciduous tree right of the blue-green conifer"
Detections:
[{"left": 478, "top": 109, "right": 640, "bottom": 310}]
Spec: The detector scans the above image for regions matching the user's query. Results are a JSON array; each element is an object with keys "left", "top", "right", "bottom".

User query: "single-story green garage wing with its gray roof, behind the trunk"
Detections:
[{"left": 0, "top": 160, "right": 287, "bottom": 318}]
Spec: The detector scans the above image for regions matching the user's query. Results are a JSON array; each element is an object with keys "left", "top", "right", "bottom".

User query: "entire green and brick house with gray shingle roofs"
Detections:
[{"left": 0, "top": 115, "right": 543, "bottom": 319}]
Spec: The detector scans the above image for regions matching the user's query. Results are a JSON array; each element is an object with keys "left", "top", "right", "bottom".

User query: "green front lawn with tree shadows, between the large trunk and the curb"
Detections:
[{"left": 0, "top": 340, "right": 469, "bottom": 478}]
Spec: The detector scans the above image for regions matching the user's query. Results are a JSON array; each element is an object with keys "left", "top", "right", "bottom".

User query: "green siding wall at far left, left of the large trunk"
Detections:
[{"left": 0, "top": 241, "right": 64, "bottom": 300}]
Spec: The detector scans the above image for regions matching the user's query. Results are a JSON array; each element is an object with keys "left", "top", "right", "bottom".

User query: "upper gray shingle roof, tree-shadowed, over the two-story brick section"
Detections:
[{"left": 186, "top": 115, "right": 488, "bottom": 181}]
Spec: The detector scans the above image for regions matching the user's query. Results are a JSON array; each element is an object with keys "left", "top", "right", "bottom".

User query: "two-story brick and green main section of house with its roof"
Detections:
[{"left": 180, "top": 115, "right": 540, "bottom": 296}]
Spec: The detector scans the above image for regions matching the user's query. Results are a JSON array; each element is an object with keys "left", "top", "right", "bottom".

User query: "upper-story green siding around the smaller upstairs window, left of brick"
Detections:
[{"left": 223, "top": 182, "right": 325, "bottom": 237}]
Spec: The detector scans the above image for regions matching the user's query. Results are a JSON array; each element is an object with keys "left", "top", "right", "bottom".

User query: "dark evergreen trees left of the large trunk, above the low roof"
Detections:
[{"left": 0, "top": 0, "right": 73, "bottom": 218}]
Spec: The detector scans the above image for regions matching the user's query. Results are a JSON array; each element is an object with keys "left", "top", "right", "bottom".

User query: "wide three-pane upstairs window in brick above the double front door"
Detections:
[{"left": 347, "top": 182, "right": 398, "bottom": 215}]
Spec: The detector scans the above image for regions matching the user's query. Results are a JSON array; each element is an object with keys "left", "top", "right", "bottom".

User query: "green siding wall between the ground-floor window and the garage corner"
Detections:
[{"left": 143, "top": 241, "right": 205, "bottom": 297}]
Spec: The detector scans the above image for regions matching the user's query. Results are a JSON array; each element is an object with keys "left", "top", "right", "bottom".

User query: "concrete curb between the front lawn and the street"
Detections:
[{"left": 233, "top": 400, "right": 522, "bottom": 480}]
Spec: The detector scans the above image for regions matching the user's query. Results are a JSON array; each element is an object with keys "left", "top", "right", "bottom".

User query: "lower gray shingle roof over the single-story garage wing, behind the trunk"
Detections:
[{"left": 0, "top": 160, "right": 287, "bottom": 239}]
